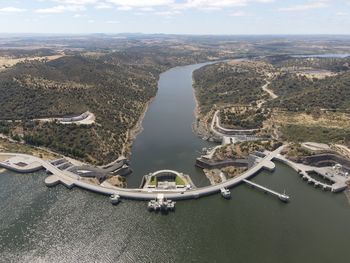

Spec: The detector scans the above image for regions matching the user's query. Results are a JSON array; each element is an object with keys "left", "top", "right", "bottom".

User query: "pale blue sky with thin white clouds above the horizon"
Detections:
[{"left": 0, "top": 0, "right": 350, "bottom": 35}]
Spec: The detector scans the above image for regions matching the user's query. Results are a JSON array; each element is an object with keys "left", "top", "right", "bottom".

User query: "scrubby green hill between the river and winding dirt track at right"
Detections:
[{"left": 193, "top": 62, "right": 267, "bottom": 114}]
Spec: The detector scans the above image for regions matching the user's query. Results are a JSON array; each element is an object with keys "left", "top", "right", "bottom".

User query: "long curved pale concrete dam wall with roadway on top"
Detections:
[{"left": 0, "top": 146, "right": 283, "bottom": 200}]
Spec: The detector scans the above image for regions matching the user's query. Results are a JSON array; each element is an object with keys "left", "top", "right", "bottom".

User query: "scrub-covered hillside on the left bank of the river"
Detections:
[{"left": 0, "top": 46, "right": 230, "bottom": 164}]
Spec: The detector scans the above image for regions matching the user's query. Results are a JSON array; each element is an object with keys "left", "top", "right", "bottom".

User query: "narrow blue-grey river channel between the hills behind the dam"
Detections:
[{"left": 128, "top": 64, "right": 213, "bottom": 187}]
